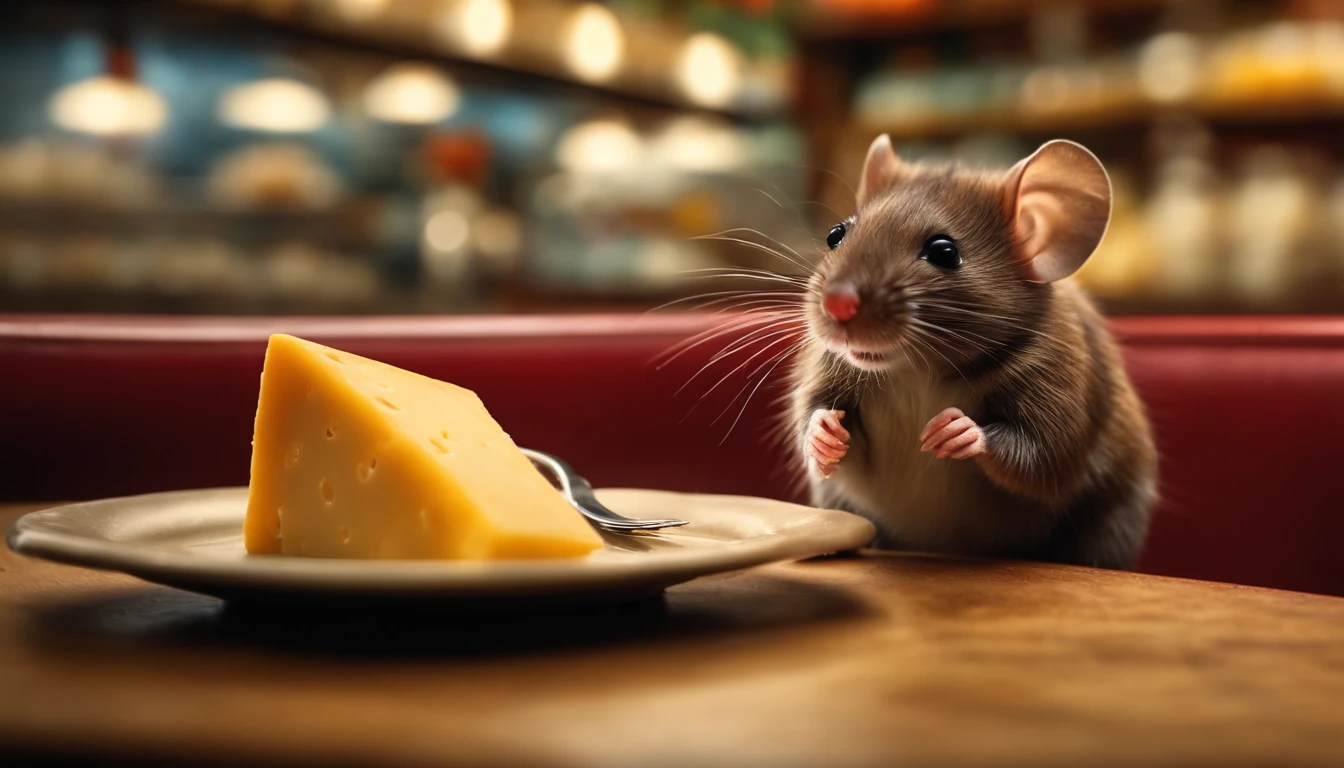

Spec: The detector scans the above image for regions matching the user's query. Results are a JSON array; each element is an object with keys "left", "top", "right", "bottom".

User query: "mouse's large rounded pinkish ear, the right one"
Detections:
[{"left": 1005, "top": 140, "right": 1110, "bottom": 282}]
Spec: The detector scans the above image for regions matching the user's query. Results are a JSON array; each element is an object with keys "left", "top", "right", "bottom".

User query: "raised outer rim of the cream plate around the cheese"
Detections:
[{"left": 5, "top": 486, "right": 876, "bottom": 596}]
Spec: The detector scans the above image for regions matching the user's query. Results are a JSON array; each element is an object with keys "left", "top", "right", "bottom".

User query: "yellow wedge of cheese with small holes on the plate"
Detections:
[{"left": 243, "top": 335, "right": 602, "bottom": 560}]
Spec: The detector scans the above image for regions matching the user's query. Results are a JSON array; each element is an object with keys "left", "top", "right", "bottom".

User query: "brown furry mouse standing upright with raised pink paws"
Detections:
[{"left": 785, "top": 135, "right": 1157, "bottom": 570}]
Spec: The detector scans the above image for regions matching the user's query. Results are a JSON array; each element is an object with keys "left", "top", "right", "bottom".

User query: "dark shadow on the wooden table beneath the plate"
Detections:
[{"left": 28, "top": 566, "right": 874, "bottom": 659}]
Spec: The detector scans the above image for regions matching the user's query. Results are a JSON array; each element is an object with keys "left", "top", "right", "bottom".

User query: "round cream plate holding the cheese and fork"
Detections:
[{"left": 8, "top": 488, "right": 874, "bottom": 603}]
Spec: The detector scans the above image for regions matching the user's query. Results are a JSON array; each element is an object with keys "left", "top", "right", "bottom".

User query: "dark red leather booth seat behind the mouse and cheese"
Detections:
[{"left": 0, "top": 315, "right": 1344, "bottom": 594}]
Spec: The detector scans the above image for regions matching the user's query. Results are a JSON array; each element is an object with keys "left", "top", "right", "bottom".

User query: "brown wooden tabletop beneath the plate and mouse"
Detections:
[{"left": 0, "top": 506, "right": 1344, "bottom": 767}]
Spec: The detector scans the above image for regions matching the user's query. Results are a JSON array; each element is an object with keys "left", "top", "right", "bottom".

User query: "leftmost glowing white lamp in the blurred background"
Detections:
[{"left": 48, "top": 77, "right": 168, "bottom": 136}]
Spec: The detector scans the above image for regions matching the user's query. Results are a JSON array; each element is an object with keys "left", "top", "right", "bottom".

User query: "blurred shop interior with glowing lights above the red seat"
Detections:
[{"left": 0, "top": 0, "right": 1344, "bottom": 315}]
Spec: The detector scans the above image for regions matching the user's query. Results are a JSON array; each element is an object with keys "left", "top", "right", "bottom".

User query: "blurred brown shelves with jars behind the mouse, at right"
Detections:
[{"left": 794, "top": 0, "right": 1344, "bottom": 313}]
